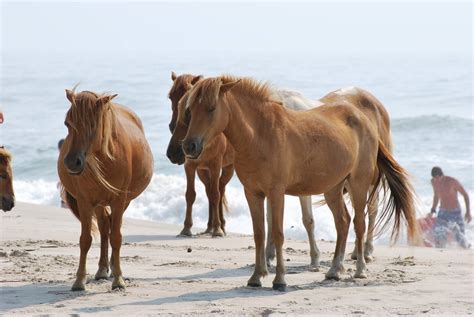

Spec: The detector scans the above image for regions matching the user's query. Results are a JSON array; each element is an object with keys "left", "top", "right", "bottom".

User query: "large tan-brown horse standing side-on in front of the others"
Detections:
[{"left": 183, "top": 76, "right": 419, "bottom": 290}]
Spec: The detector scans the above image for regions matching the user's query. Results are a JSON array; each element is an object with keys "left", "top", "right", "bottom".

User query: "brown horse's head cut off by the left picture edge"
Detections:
[{"left": 0, "top": 146, "right": 15, "bottom": 211}]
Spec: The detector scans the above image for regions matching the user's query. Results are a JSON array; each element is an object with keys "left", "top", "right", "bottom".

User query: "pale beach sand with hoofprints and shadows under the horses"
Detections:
[{"left": 0, "top": 203, "right": 474, "bottom": 316}]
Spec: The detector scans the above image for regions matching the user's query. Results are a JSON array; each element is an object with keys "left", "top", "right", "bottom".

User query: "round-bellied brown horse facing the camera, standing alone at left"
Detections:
[{"left": 58, "top": 90, "right": 153, "bottom": 291}]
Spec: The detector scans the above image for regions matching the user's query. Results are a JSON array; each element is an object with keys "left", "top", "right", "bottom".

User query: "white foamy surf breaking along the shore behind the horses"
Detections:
[{"left": 14, "top": 174, "right": 474, "bottom": 244}]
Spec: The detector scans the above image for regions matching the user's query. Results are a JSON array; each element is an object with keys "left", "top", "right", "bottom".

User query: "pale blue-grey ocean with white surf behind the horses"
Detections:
[{"left": 0, "top": 51, "right": 474, "bottom": 243}]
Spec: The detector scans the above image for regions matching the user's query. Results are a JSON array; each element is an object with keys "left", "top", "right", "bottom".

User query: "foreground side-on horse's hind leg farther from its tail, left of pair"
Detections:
[{"left": 324, "top": 182, "right": 351, "bottom": 280}]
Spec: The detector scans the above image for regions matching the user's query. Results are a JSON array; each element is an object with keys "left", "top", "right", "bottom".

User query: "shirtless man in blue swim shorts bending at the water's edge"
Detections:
[{"left": 431, "top": 166, "right": 472, "bottom": 248}]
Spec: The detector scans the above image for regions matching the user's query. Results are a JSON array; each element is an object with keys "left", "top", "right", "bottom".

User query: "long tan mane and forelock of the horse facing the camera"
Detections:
[{"left": 66, "top": 89, "right": 119, "bottom": 194}]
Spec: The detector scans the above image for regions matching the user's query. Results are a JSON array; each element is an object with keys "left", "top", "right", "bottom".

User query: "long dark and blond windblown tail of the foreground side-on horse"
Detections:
[{"left": 369, "top": 141, "right": 421, "bottom": 245}]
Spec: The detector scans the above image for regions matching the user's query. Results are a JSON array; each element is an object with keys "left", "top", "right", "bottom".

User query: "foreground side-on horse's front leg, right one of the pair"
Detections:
[{"left": 268, "top": 190, "right": 286, "bottom": 291}]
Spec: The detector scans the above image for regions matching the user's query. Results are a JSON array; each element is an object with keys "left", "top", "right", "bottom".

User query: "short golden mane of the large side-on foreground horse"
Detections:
[{"left": 187, "top": 75, "right": 272, "bottom": 106}]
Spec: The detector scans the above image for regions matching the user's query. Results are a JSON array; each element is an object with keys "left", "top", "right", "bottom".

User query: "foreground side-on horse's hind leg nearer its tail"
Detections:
[{"left": 349, "top": 178, "right": 369, "bottom": 278}]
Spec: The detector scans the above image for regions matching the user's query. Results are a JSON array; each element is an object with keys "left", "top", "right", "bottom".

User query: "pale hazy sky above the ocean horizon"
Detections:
[{"left": 1, "top": 0, "right": 472, "bottom": 53}]
